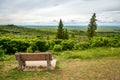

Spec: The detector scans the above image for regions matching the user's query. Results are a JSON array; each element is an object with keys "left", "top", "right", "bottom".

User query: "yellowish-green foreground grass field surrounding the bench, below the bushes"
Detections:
[{"left": 0, "top": 48, "right": 120, "bottom": 80}]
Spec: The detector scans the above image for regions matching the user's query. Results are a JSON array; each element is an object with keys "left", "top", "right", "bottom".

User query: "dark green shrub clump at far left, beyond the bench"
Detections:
[{"left": 0, "top": 38, "right": 30, "bottom": 54}]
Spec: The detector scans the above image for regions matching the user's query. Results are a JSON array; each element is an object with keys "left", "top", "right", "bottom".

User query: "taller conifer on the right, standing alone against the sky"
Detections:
[{"left": 87, "top": 13, "right": 97, "bottom": 38}]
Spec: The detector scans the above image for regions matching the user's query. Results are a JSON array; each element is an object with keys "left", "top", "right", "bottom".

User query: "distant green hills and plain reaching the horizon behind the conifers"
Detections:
[{"left": 0, "top": 25, "right": 120, "bottom": 39}]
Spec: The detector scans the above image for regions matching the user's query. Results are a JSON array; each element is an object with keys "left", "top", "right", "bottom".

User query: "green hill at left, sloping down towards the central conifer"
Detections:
[{"left": 0, "top": 25, "right": 55, "bottom": 38}]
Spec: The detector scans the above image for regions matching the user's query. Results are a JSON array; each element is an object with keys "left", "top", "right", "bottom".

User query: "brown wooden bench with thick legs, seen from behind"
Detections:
[{"left": 15, "top": 52, "right": 52, "bottom": 70}]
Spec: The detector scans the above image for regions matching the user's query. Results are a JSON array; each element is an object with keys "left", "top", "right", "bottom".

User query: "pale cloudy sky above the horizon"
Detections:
[{"left": 0, "top": 0, "right": 120, "bottom": 25}]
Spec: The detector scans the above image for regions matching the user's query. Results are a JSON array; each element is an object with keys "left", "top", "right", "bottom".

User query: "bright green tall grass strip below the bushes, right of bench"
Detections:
[{"left": 60, "top": 47, "right": 120, "bottom": 59}]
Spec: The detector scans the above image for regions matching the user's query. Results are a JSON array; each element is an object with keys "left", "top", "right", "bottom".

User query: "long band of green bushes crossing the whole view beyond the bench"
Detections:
[{"left": 0, "top": 36, "right": 120, "bottom": 54}]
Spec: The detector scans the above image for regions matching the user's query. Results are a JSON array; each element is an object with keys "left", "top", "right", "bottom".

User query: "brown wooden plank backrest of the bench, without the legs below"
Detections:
[{"left": 15, "top": 52, "right": 52, "bottom": 61}]
